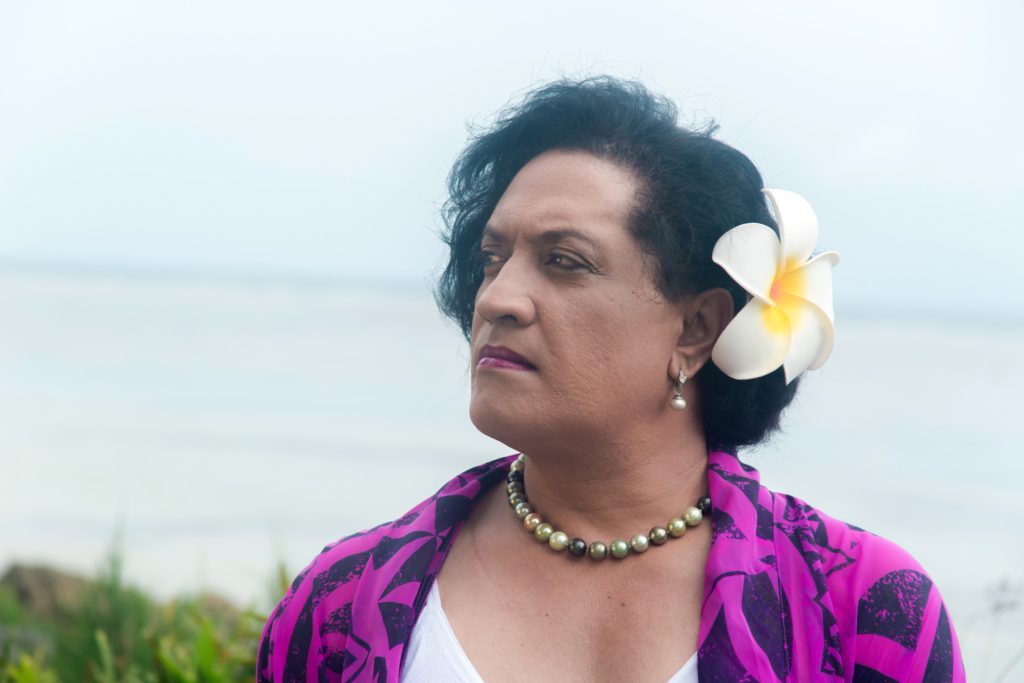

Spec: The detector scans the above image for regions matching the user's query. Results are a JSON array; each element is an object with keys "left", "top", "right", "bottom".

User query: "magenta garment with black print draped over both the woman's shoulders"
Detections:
[{"left": 256, "top": 452, "right": 966, "bottom": 683}]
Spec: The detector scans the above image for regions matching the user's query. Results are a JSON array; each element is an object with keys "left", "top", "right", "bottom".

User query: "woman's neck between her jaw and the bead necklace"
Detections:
[{"left": 523, "top": 421, "right": 708, "bottom": 543}]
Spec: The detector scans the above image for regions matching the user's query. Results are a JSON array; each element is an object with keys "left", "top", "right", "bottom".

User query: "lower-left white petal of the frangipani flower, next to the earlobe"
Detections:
[{"left": 711, "top": 299, "right": 791, "bottom": 380}]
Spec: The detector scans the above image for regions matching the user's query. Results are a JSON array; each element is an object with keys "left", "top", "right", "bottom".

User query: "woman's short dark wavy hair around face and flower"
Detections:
[{"left": 435, "top": 76, "right": 799, "bottom": 452}]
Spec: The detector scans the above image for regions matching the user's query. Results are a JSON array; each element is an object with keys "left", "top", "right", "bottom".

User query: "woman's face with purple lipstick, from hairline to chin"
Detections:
[{"left": 470, "top": 151, "right": 682, "bottom": 451}]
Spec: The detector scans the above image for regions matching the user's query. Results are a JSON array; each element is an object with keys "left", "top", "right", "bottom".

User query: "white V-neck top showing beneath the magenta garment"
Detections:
[{"left": 401, "top": 580, "right": 697, "bottom": 683}]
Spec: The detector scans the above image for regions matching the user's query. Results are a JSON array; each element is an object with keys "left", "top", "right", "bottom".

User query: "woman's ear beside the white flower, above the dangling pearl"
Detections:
[{"left": 669, "top": 287, "right": 733, "bottom": 379}]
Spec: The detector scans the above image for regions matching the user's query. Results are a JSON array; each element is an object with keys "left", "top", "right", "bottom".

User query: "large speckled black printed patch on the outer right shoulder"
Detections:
[{"left": 857, "top": 569, "right": 932, "bottom": 650}]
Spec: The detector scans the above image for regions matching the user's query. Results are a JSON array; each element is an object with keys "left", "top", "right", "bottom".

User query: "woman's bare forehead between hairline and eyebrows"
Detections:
[{"left": 487, "top": 150, "right": 637, "bottom": 238}]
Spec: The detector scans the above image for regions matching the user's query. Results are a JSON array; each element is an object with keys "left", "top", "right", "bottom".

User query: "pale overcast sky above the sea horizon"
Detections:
[{"left": 0, "top": 0, "right": 1024, "bottom": 319}]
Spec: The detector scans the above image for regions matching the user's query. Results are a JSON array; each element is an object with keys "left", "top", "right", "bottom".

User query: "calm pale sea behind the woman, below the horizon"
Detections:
[{"left": 0, "top": 269, "right": 1024, "bottom": 681}]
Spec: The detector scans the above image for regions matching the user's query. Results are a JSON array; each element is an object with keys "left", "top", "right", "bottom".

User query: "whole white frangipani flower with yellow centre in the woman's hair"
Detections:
[{"left": 711, "top": 189, "right": 839, "bottom": 384}]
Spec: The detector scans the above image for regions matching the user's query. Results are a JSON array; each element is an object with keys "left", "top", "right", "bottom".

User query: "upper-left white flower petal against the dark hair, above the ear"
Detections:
[{"left": 711, "top": 223, "right": 780, "bottom": 304}]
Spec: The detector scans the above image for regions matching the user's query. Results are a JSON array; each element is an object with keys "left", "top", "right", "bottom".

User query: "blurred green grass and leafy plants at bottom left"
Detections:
[{"left": 0, "top": 550, "right": 287, "bottom": 683}]
